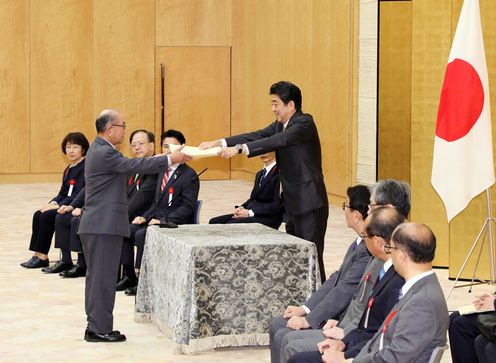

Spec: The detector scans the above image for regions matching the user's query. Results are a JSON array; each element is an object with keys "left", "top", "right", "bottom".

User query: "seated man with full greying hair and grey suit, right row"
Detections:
[{"left": 274, "top": 179, "right": 410, "bottom": 363}]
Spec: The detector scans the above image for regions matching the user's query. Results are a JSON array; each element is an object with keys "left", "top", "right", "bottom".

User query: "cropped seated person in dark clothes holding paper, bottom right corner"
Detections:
[{"left": 448, "top": 294, "right": 496, "bottom": 363}]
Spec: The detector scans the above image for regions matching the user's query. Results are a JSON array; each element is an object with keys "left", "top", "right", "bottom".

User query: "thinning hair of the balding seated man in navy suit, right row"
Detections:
[{"left": 365, "top": 207, "right": 405, "bottom": 243}]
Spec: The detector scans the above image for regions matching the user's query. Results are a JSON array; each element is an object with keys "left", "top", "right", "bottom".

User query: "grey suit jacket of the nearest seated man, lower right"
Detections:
[{"left": 353, "top": 274, "right": 449, "bottom": 363}]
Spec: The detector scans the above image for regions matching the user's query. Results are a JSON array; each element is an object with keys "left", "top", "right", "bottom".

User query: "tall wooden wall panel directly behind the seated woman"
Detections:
[{"left": 30, "top": 0, "right": 92, "bottom": 173}]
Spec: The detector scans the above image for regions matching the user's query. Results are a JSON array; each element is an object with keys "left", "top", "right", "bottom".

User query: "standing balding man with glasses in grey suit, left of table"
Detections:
[{"left": 78, "top": 110, "right": 191, "bottom": 342}]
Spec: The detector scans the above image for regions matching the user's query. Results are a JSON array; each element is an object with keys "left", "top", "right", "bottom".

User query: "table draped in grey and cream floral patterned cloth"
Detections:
[{"left": 135, "top": 224, "right": 320, "bottom": 353}]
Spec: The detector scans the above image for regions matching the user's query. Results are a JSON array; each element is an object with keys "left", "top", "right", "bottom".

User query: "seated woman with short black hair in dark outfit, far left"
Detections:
[{"left": 21, "top": 132, "right": 89, "bottom": 272}]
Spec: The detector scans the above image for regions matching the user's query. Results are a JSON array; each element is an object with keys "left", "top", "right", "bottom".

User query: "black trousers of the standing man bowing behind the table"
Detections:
[{"left": 286, "top": 206, "right": 329, "bottom": 283}]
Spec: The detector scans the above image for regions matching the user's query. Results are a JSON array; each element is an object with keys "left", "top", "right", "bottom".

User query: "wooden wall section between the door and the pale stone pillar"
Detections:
[{"left": 232, "top": 0, "right": 356, "bottom": 202}]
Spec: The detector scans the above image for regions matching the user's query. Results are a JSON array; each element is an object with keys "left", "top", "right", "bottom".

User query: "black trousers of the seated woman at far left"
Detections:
[{"left": 29, "top": 209, "right": 58, "bottom": 255}]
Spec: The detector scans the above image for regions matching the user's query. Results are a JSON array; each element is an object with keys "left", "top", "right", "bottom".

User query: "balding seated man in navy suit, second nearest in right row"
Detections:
[{"left": 281, "top": 207, "right": 405, "bottom": 362}]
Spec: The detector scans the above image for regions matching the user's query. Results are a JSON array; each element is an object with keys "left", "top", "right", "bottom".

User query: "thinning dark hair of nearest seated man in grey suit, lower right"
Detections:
[{"left": 392, "top": 223, "right": 436, "bottom": 263}]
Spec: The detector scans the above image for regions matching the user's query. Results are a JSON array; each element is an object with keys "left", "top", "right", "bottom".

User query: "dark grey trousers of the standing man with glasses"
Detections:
[{"left": 79, "top": 234, "right": 123, "bottom": 334}]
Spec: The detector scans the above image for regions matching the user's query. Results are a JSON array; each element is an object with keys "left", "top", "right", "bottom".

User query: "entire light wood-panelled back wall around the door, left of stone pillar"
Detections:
[{"left": 0, "top": 0, "right": 358, "bottom": 205}]
